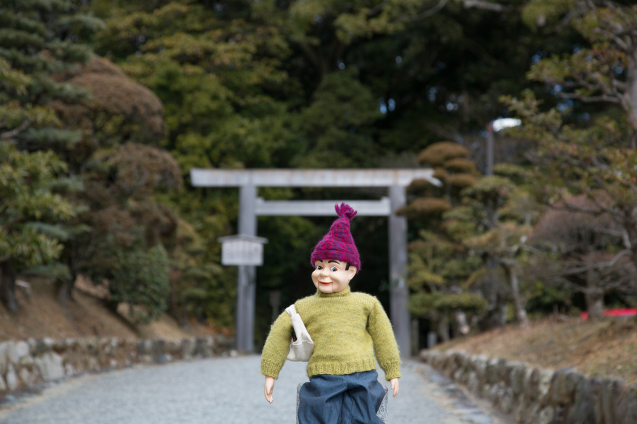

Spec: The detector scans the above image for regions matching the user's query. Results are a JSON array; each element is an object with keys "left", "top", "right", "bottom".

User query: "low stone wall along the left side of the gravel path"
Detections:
[{"left": 0, "top": 334, "right": 234, "bottom": 397}]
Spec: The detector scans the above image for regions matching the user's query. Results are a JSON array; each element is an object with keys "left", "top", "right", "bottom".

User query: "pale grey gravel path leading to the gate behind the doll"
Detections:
[{"left": 0, "top": 356, "right": 505, "bottom": 424}]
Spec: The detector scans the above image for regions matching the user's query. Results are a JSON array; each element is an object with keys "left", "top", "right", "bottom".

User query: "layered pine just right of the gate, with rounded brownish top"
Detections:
[{"left": 402, "top": 142, "right": 537, "bottom": 340}]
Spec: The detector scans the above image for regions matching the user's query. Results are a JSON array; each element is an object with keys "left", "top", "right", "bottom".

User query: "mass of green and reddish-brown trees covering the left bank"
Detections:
[{"left": 0, "top": 1, "right": 181, "bottom": 322}]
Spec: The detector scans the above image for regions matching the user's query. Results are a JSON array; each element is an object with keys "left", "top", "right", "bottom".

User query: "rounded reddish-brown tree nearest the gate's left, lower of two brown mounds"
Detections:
[{"left": 76, "top": 143, "right": 182, "bottom": 322}]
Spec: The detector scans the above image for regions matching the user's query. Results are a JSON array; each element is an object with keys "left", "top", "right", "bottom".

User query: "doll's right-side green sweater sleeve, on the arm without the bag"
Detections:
[{"left": 368, "top": 298, "right": 401, "bottom": 381}]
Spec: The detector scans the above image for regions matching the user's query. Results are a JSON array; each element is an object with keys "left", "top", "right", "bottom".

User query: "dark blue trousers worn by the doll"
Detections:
[{"left": 299, "top": 371, "right": 385, "bottom": 424}]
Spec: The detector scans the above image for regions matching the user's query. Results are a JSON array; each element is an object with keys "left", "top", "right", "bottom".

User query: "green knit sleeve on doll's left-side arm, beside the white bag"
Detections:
[{"left": 261, "top": 311, "right": 293, "bottom": 379}]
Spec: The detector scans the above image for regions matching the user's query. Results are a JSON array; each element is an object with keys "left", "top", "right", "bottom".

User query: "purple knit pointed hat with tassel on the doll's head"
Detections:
[{"left": 310, "top": 203, "right": 361, "bottom": 273}]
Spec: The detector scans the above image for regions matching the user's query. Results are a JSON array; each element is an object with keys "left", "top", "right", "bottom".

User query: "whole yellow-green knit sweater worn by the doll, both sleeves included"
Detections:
[{"left": 261, "top": 287, "right": 400, "bottom": 381}]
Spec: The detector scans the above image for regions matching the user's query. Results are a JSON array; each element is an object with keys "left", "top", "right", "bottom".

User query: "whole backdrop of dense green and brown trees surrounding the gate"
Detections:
[{"left": 0, "top": 0, "right": 637, "bottom": 345}]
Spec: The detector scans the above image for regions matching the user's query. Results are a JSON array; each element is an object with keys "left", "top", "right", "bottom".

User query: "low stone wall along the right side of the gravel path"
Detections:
[{"left": 420, "top": 350, "right": 637, "bottom": 424}]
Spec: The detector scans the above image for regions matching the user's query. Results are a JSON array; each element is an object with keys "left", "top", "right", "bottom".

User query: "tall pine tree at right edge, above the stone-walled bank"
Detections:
[{"left": 502, "top": 2, "right": 637, "bottom": 318}]
